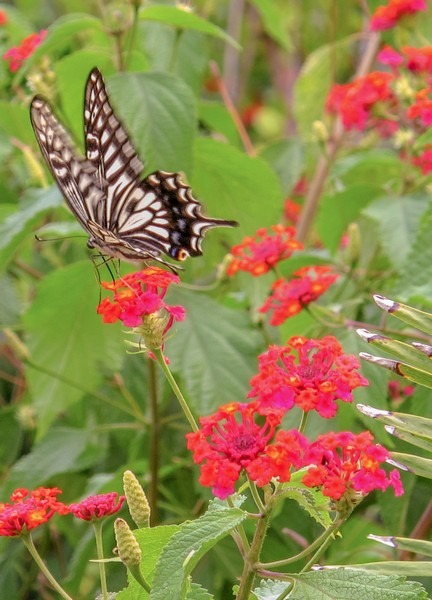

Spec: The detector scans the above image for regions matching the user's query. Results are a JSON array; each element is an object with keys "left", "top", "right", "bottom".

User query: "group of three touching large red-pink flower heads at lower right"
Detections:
[{"left": 186, "top": 336, "right": 403, "bottom": 501}]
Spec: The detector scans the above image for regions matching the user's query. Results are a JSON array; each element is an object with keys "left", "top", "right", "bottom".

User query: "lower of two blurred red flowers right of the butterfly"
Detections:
[{"left": 259, "top": 266, "right": 338, "bottom": 326}]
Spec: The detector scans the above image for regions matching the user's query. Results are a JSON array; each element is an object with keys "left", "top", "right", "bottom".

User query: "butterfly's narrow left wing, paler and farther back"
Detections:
[{"left": 30, "top": 96, "right": 103, "bottom": 233}]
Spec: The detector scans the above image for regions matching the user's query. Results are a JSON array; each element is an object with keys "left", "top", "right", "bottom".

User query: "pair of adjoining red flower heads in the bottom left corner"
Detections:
[{"left": 0, "top": 487, "right": 125, "bottom": 537}]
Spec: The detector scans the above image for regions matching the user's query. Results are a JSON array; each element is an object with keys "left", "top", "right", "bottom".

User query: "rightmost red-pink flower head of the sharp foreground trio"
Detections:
[{"left": 302, "top": 431, "right": 403, "bottom": 500}]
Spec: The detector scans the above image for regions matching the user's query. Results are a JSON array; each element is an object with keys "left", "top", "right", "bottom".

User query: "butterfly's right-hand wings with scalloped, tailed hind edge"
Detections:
[{"left": 85, "top": 69, "right": 237, "bottom": 262}]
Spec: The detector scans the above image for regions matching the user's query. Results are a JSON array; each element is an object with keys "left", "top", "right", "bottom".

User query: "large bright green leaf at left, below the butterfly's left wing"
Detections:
[{"left": 24, "top": 261, "right": 123, "bottom": 436}]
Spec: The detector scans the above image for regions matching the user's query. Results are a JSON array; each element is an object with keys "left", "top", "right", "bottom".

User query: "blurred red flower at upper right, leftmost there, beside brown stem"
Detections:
[{"left": 326, "top": 71, "right": 395, "bottom": 131}]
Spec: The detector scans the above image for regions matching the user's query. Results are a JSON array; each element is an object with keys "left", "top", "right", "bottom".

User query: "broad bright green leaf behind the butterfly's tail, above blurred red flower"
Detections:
[{"left": 191, "top": 138, "right": 283, "bottom": 239}]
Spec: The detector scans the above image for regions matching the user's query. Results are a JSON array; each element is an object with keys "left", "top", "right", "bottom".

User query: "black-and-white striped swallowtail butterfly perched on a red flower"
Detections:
[{"left": 30, "top": 68, "right": 238, "bottom": 271}]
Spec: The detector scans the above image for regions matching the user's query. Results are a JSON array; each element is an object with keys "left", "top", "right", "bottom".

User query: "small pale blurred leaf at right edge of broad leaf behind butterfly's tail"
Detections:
[{"left": 259, "top": 138, "right": 304, "bottom": 196}]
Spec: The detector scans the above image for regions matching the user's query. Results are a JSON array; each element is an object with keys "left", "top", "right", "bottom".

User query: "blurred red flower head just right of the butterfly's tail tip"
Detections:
[{"left": 227, "top": 225, "right": 303, "bottom": 277}]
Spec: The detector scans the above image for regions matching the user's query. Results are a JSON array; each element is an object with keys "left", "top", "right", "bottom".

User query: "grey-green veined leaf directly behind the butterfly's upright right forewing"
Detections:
[{"left": 107, "top": 73, "right": 196, "bottom": 174}]
